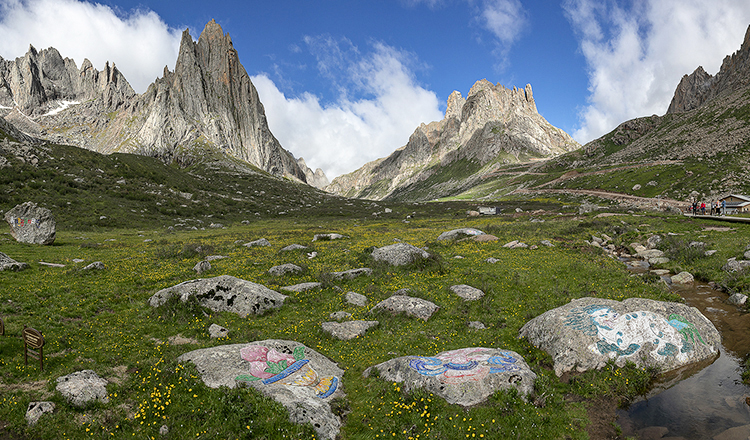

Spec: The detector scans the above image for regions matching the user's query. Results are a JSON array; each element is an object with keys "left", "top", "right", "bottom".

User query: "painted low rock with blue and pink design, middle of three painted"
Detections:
[{"left": 363, "top": 347, "right": 536, "bottom": 406}]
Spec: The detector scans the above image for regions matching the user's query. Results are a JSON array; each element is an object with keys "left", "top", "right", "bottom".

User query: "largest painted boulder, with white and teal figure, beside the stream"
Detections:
[{"left": 519, "top": 298, "right": 721, "bottom": 376}]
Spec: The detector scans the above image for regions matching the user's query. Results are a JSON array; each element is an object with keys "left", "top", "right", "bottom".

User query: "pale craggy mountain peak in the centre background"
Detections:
[{"left": 326, "top": 80, "right": 580, "bottom": 200}]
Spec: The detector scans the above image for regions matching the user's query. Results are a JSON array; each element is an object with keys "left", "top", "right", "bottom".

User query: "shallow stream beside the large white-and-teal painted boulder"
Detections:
[{"left": 618, "top": 282, "right": 750, "bottom": 440}]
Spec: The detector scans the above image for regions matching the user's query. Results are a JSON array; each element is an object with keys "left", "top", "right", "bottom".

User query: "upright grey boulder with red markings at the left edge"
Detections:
[{"left": 4, "top": 202, "right": 56, "bottom": 245}]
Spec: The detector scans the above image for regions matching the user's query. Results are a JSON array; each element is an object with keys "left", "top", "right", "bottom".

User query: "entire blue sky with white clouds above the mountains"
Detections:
[{"left": 0, "top": 0, "right": 750, "bottom": 177}]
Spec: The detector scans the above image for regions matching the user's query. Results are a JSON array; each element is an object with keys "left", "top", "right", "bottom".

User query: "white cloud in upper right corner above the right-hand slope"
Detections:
[{"left": 563, "top": 0, "right": 750, "bottom": 143}]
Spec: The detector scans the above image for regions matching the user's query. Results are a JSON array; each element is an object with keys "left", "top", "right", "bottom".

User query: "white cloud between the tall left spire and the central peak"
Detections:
[{"left": 252, "top": 40, "right": 444, "bottom": 179}]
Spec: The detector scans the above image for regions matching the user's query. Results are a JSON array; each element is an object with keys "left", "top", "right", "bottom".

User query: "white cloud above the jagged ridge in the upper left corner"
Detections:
[{"left": 0, "top": 0, "right": 181, "bottom": 93}]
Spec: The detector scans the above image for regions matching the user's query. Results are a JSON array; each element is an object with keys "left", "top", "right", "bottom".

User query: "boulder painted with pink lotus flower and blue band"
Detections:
[{"left": 177, "top": 339, "right": 345, "bottom": 439}]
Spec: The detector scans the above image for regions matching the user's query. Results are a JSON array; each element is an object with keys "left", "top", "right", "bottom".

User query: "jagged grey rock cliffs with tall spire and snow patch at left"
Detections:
[{"left": 0, "top": 20, "right": 306, "bottom": 182}]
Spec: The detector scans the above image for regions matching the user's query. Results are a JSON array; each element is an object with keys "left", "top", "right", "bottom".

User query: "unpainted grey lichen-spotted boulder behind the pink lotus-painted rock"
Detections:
[{"left": 148, "top": 275, "right": 286, "bottom": 318}]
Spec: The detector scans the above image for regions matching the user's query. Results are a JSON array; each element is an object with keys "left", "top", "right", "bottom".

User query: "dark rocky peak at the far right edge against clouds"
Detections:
[{"left": 667, "top": 26, "right": 750, "bottom": 113}]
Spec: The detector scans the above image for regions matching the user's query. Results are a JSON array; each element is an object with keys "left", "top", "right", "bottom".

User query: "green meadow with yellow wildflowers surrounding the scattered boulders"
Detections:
[{"left": 0, "top": 206, "right": 750, "bottom": 439}]
